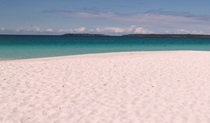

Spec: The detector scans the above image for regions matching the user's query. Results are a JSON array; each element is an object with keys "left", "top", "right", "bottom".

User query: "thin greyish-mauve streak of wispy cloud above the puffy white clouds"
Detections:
[{"left": 43, "top": 10, "right": 210, "bottom": 24}]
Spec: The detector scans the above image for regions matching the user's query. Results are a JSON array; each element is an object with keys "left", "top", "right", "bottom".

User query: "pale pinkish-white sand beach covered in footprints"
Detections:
[{"left": 0, "top": 51, "right": 210, "bottom": 123}]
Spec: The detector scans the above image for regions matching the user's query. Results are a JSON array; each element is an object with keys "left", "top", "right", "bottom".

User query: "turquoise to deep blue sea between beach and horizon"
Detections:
[{"left": 0, "top": 35, "right": 210, "bottom": 59}]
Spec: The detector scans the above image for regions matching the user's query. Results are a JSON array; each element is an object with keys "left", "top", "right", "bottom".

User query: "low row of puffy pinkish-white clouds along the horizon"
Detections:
[{"left": 0, "top": 25, "right": 210, "bottom": 35}]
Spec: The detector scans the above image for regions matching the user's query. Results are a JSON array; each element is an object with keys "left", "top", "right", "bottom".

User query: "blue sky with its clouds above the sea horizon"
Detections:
[{"left": 0, "top": 0, "right": 210, "bottom": 35}]
